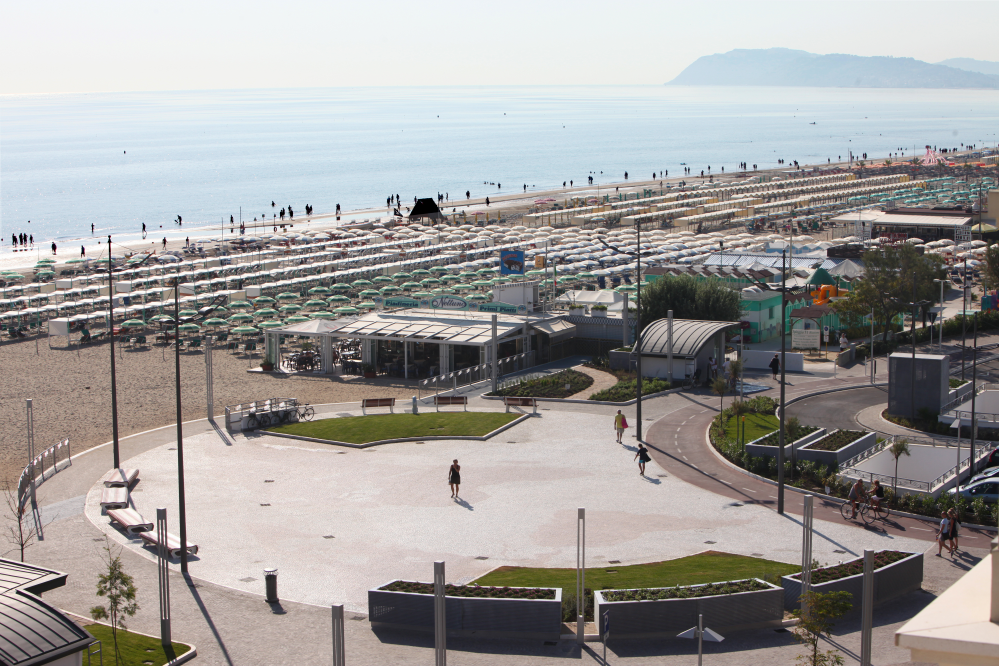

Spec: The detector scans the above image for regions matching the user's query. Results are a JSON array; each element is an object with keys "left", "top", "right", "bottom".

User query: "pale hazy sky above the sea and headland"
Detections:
[{"left": 0, "top": 0, "right": 999, "bottom": 93}]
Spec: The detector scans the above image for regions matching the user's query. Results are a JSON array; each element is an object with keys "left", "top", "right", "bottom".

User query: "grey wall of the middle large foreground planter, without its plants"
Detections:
[{"left": 593, "top": 581, "right": 784, "bottom": 640}]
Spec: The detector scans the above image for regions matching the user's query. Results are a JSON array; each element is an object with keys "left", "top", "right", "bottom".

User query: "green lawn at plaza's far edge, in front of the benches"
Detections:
[{"left": 267, "top": 412, "right": 520, "bottom": 444}]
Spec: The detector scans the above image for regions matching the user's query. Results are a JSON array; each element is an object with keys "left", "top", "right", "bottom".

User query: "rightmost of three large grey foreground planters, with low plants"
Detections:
[{"left": 781, "top": 550, "right": 923, "bottom": 614}]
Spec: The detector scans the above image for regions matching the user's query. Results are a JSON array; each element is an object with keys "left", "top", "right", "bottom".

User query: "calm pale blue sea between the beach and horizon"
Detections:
[{"left": 0, "top": 86, "right": 999, "bottom": 250}]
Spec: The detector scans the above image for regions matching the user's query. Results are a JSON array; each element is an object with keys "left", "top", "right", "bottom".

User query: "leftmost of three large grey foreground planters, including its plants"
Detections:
[{"left": 368, "top": 581, "right": 562, "bottom": 641}]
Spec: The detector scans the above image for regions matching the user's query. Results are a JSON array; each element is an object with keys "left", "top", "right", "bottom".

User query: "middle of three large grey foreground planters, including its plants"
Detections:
[{"left": 594, "top": 579, "right": 784, "bottom": 639}]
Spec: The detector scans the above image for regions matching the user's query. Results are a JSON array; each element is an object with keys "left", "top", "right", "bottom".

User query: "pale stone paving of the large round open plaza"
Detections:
[{"left": 86, "top": 411, "right": 926, "bottom": 612}]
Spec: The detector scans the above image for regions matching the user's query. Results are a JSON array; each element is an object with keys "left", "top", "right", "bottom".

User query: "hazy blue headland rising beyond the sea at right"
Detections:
[{"left": 666, "top": 48, "right": 999, "bottom": 89}]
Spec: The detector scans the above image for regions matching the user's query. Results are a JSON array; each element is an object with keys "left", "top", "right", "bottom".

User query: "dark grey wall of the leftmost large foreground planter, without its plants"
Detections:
[{"left": 368, "top": 581, "right": 562, "bottom": 641}]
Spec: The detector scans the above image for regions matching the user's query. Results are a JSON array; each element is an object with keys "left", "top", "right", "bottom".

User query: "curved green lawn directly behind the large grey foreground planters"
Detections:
[{"left": 474, "top": 552, "right": 801, "bottom": 590}]
